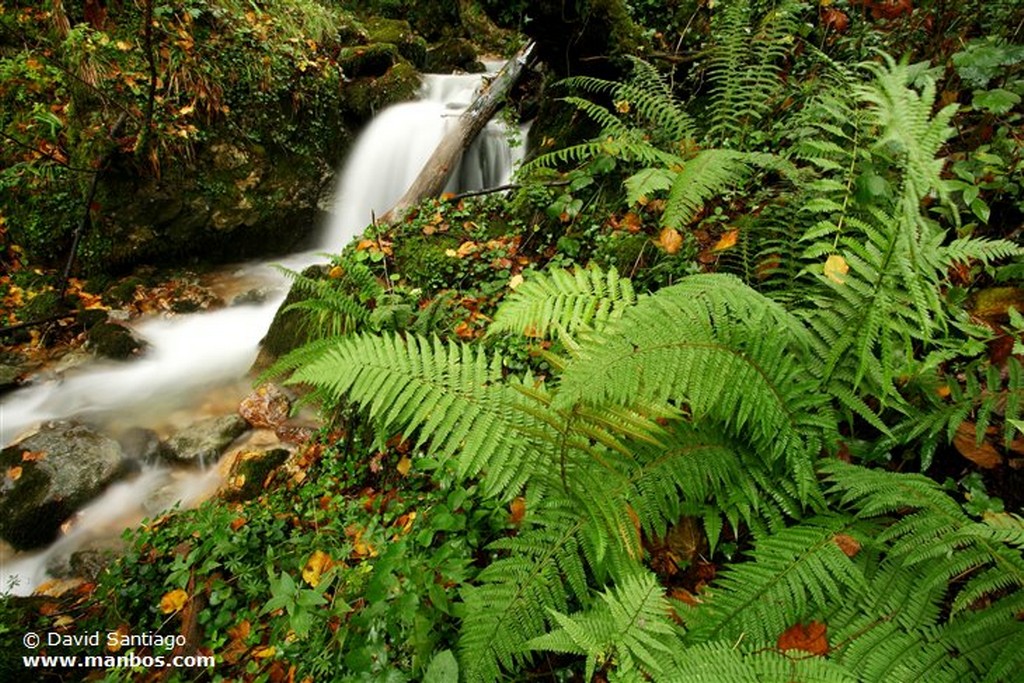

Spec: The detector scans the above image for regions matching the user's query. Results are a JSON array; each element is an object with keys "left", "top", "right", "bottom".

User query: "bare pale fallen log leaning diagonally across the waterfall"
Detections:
[{"left": 375, "top": 43, "right": 534, "bottom": 223}]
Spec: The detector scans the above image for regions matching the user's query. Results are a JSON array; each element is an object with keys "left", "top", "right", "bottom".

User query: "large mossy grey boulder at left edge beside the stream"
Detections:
[{"left": 0, "top": 422, "right": 130, "bottom": 550}]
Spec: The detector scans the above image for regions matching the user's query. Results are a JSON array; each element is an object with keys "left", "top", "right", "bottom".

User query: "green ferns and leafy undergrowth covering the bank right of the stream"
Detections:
[{"left": 3, "top": 0, "right": 1024, "bottom": 683}]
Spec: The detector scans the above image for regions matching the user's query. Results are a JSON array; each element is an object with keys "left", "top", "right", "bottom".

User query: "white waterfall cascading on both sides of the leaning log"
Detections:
[{"left": 319, "top": 63, "right": 522, "bottom": 251}]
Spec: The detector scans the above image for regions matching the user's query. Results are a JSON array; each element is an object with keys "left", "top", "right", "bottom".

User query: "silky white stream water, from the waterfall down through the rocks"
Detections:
[{"left": 0, "top": 65, "right": 517, "bottom": 595}]
